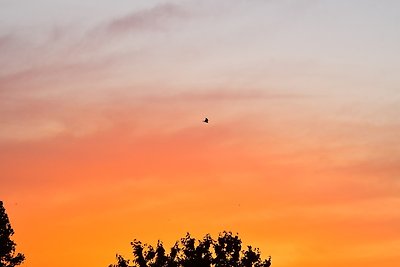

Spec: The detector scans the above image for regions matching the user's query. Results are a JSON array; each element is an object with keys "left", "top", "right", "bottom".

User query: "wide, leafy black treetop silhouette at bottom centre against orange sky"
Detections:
[{"left": 109, "top": 231, "right": 271, "bottom": 267}]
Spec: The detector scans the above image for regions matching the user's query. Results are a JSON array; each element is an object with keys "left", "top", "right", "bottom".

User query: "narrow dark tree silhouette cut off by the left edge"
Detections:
[{"left": 0, "top": 201, "right": 25, "bottom": 267}]
